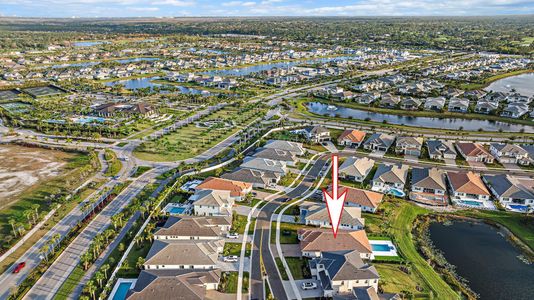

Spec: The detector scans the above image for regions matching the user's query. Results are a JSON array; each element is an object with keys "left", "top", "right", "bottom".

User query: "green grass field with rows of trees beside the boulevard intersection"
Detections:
[{"left": 134, "top": 105, "right": 264, "bottom": 161}]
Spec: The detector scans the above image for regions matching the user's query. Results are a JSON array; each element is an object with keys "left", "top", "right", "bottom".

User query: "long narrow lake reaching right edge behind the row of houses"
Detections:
[{"left": 308, "top": 102, "right": 534, "bottom": 132}]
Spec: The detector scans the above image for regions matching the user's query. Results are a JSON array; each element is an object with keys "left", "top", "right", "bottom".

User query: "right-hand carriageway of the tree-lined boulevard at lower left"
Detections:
[{"left": 23, "top": 168, "right": 166, "bottom": 299}]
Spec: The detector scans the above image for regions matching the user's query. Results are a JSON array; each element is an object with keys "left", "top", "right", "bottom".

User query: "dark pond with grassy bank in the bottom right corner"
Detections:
[{"left": 430, "top": 221, "right": 534, "bottom": 300}]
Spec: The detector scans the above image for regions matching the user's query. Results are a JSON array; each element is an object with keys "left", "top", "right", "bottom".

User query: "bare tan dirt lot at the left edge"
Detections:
[{"left": 0, "top": 145, "right": 73, "bottom": 209}]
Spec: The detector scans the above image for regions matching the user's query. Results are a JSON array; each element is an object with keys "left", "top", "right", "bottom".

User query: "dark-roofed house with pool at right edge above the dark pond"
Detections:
[{"left": 482, "top": 174, "right": 534, "bottom": 211}]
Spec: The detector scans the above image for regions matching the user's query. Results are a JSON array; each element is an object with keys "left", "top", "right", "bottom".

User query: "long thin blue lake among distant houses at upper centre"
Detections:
[{"left": 200, "top": 56, "right": 356, "bottom": 76}]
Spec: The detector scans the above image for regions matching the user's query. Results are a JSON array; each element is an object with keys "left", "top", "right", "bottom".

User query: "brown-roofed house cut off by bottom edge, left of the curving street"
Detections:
[{"left": 126, "top": 270, "right": 221, "bottom": 300}]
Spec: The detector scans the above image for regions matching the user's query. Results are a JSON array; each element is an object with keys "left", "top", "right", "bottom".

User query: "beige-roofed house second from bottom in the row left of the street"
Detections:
[{"left": 143, "top": 239, "right": 224, "bottom": 270}]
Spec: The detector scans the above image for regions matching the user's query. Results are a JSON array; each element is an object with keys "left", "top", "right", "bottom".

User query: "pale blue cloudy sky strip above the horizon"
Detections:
[{"left": 0, "top": 0, "right": 534, "bottom": 18}]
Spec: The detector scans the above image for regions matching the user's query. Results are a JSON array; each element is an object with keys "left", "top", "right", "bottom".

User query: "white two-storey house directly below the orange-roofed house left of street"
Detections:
[{"left": 193, "top": 190, "right": 235, "bottom": 216}]
